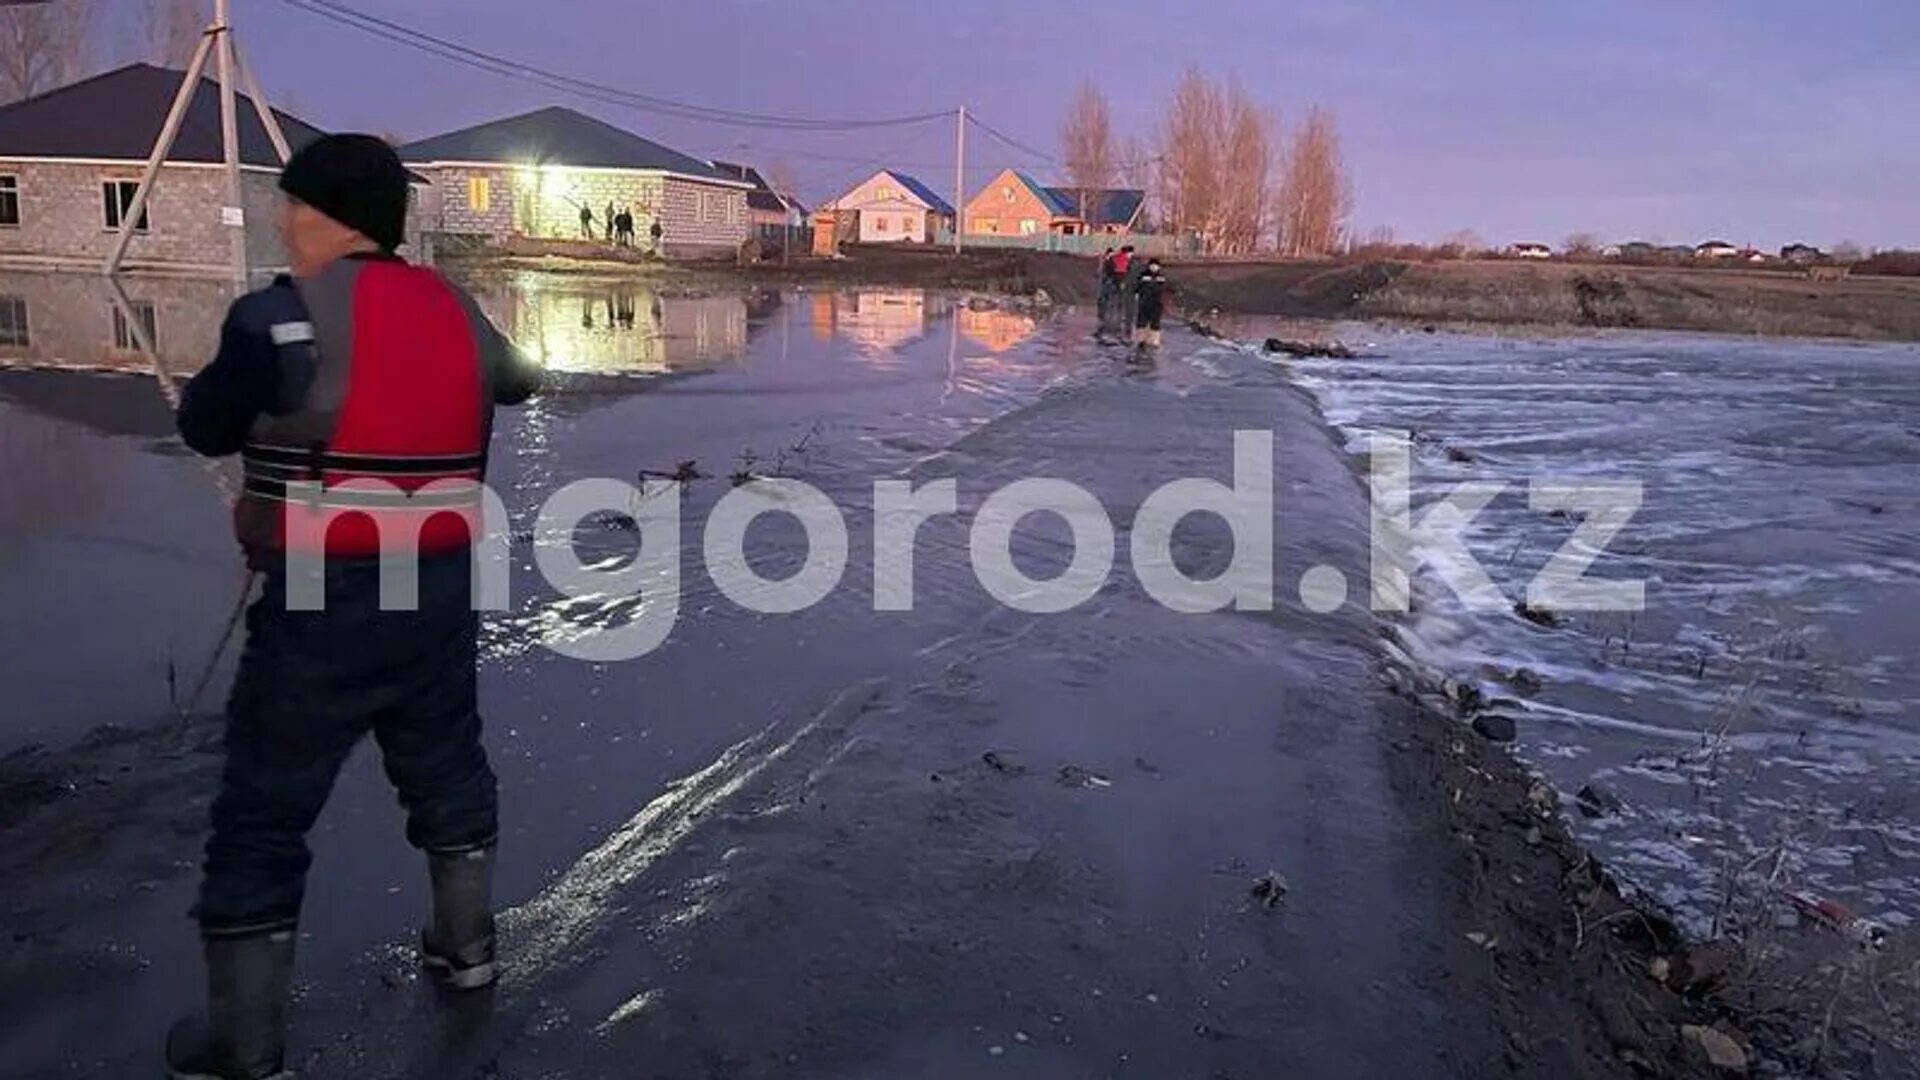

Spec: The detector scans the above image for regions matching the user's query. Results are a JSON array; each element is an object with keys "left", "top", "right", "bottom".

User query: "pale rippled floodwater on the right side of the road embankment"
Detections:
[{"left": 1288, "top": 329, "right": 1920, "bottom": 932}]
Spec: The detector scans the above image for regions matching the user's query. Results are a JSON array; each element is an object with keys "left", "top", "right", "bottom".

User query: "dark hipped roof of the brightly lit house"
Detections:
[{"left": 399, "top": 106, "right": 741, "bottom": 183}]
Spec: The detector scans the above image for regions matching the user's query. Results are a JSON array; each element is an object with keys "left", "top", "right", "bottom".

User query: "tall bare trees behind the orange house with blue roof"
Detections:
[{"left": 1060, "top": 67, "right": 1354, "bottom": 256}]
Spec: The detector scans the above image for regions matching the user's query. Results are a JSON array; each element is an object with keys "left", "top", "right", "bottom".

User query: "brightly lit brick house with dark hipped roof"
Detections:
[{"left": 399, "top": 106, "right": 753, "bottom": 258}]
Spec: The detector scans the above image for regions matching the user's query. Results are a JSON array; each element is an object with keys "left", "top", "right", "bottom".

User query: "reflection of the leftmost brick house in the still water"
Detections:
[{"left": 0, "top": 271, "right": 232, "bottom": 377}]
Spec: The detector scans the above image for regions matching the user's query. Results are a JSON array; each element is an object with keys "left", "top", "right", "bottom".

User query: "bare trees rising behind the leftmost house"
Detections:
[{"left": 0, "top": 0, "right": 213, "bottom": 102}]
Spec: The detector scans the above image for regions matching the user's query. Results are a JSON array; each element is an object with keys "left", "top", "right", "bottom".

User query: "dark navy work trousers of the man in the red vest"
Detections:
[{"left": 194, "top": 552, "right": 497, "bottom": 936}]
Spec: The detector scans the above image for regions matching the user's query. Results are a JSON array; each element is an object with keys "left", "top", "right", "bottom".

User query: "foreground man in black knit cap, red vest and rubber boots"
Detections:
[{"left": 167, "top": 135, "right": 540, "bottom": 1080}]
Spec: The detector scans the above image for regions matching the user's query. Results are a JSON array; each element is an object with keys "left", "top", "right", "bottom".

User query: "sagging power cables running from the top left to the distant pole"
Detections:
[{"left": 266, "top": 0, "right": 954, "bottom": 131}]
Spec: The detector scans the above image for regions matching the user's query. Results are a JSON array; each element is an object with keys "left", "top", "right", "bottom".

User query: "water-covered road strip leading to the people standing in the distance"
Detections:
[{"left": 295, "top": 317, "right": 1503, "bottom": 1080}]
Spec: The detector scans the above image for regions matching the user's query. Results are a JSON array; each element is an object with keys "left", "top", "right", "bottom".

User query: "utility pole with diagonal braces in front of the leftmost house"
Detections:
[{"left": 104, "top": 0, "right": 288, "bottom": 282}]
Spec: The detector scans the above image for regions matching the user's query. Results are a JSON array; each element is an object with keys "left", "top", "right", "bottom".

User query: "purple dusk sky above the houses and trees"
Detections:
[{"left": 82, "top": 0, "right": 1920, "bottom": 252}]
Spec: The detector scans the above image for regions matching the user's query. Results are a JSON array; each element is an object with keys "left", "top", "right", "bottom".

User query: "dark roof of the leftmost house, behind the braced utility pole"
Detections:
[{"left": 0, "top": 63, "right": 321, "bottom": 169}]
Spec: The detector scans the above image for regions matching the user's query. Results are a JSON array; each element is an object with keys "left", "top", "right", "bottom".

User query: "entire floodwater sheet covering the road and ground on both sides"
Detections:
[{"left": 0, "top": 267, "right": 1920, "bottom": 1080}]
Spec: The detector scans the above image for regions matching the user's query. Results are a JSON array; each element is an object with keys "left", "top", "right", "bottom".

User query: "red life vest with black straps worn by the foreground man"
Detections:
[{"left": 234, "top": 259, "right": 490, "bottom": 557}]
